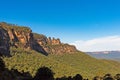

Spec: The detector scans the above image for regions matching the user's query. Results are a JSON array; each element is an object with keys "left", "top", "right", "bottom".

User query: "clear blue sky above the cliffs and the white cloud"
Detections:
[{"left": 0, "top": 0, "right": 120, "bottom": 51}]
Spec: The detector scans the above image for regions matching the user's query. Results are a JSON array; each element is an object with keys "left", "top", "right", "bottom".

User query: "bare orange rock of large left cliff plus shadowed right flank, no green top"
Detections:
[{"left": 8, "top": 29, "right": 46, "bottom": 54}]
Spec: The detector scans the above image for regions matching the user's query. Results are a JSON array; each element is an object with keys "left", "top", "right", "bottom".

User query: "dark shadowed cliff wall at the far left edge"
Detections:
[{"left": 0, "top": 25, "right": 10, "bottom": 56}]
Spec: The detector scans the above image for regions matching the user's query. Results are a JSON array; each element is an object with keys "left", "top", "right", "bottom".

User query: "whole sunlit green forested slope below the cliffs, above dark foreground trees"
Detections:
[{"left": 3, "top": 48, "right": 120, "bottom": 79}]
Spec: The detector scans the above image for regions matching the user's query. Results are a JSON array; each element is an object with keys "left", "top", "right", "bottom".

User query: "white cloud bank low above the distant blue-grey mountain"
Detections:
[{"left": 70, "top": 36, "right": 120, "bottom": 52}]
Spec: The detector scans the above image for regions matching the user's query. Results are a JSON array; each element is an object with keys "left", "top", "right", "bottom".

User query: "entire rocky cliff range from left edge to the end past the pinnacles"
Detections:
[{"left": 0, "top": 23, "right": 77, "bottom": 55}]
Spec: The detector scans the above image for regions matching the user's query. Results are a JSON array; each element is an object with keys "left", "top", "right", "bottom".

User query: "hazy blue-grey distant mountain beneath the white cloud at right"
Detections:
[{"left": 86, "top": 51, "right": 120, "bottom": 60}]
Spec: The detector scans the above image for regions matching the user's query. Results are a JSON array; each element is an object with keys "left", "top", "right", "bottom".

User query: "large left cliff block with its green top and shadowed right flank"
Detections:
[{"left": 0, "top": 23, "right": 47, "bottom": 55}]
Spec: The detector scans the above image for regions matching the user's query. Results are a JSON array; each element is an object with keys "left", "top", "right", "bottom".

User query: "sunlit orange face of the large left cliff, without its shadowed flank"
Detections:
[{"left": 8, "top": 29, "right": 33, "bottom": 49}]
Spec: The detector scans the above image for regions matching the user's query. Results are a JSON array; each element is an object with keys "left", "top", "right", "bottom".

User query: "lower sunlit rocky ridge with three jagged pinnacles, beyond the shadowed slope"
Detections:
[{"left": 34, "top": 34, "right": 77, "bottom": 54}]
